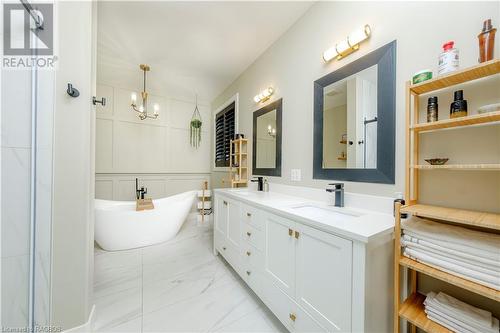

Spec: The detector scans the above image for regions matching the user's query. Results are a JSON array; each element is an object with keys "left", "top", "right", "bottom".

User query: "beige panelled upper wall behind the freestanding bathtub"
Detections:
[{"left": 96, "top": 84, "right": 212, "bottom": 174}]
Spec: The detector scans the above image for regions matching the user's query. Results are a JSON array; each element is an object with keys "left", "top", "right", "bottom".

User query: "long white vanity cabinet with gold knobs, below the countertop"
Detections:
[{"left": 214, "top": 193, "right": 392, "bottom": 332}]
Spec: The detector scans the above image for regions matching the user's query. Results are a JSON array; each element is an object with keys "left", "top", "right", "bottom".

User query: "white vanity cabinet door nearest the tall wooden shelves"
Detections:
[{"left": 295, "top": 224, "right": 352, "bottom": 332}]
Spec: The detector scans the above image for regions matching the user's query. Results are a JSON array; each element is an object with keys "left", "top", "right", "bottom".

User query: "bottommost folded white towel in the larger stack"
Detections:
[{"left": 403, "top": 248, "right": 500, "bottom": 290}]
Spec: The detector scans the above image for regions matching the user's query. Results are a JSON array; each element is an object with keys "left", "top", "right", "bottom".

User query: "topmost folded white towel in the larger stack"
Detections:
[{"left": 401, "top": 216, "right": 500, "bottom": 255}]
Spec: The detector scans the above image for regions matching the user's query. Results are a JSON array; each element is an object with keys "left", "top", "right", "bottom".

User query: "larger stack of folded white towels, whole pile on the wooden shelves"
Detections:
[{"left": 401, "top": 217, "right": 500, "bottom": 290}]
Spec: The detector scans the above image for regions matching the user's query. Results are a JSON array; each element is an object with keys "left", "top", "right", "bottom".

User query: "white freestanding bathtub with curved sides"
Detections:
[{"left": 95, "top": 191, "right": 196, "bottom": 251}]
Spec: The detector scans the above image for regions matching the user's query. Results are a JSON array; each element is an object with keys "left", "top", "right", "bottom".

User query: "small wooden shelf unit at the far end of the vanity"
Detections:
[{"left": 229, "top": 139, "right": 248, "bottom": 187}]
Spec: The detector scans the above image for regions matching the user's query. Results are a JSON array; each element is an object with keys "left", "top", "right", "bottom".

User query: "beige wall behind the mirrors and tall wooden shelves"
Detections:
[{"left": 212, "top": 2, "right": 500, "bottom": 317}]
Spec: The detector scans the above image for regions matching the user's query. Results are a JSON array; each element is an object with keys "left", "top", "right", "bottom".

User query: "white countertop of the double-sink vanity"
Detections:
[{"left": 214, "top": 189, "right": 394, "bottom": 243}]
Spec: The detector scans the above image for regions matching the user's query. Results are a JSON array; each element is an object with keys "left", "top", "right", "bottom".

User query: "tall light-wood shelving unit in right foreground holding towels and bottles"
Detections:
[{"left": 394, "top": 59, "right": 500, "bottom": 333}]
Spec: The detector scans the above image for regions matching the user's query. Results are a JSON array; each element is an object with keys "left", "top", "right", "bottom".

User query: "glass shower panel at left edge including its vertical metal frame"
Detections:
[{"left": 0, "top": 34, "right": 54, "bottom": 332}]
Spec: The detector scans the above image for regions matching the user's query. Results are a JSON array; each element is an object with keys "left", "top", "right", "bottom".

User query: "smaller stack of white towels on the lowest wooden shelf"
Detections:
[{"left": 424, "top": 292, "right": 499, "bottom": 333}]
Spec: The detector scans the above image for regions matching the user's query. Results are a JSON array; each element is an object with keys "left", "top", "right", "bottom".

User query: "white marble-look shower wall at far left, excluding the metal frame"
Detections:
[{"left": 1, "top": 69, "right": 32, "bottom": 329}]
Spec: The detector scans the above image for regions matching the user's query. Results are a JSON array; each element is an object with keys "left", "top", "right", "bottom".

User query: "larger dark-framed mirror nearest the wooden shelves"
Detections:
[{"left": 313, "top": 41, "right": 396, "bottom": 184}]
